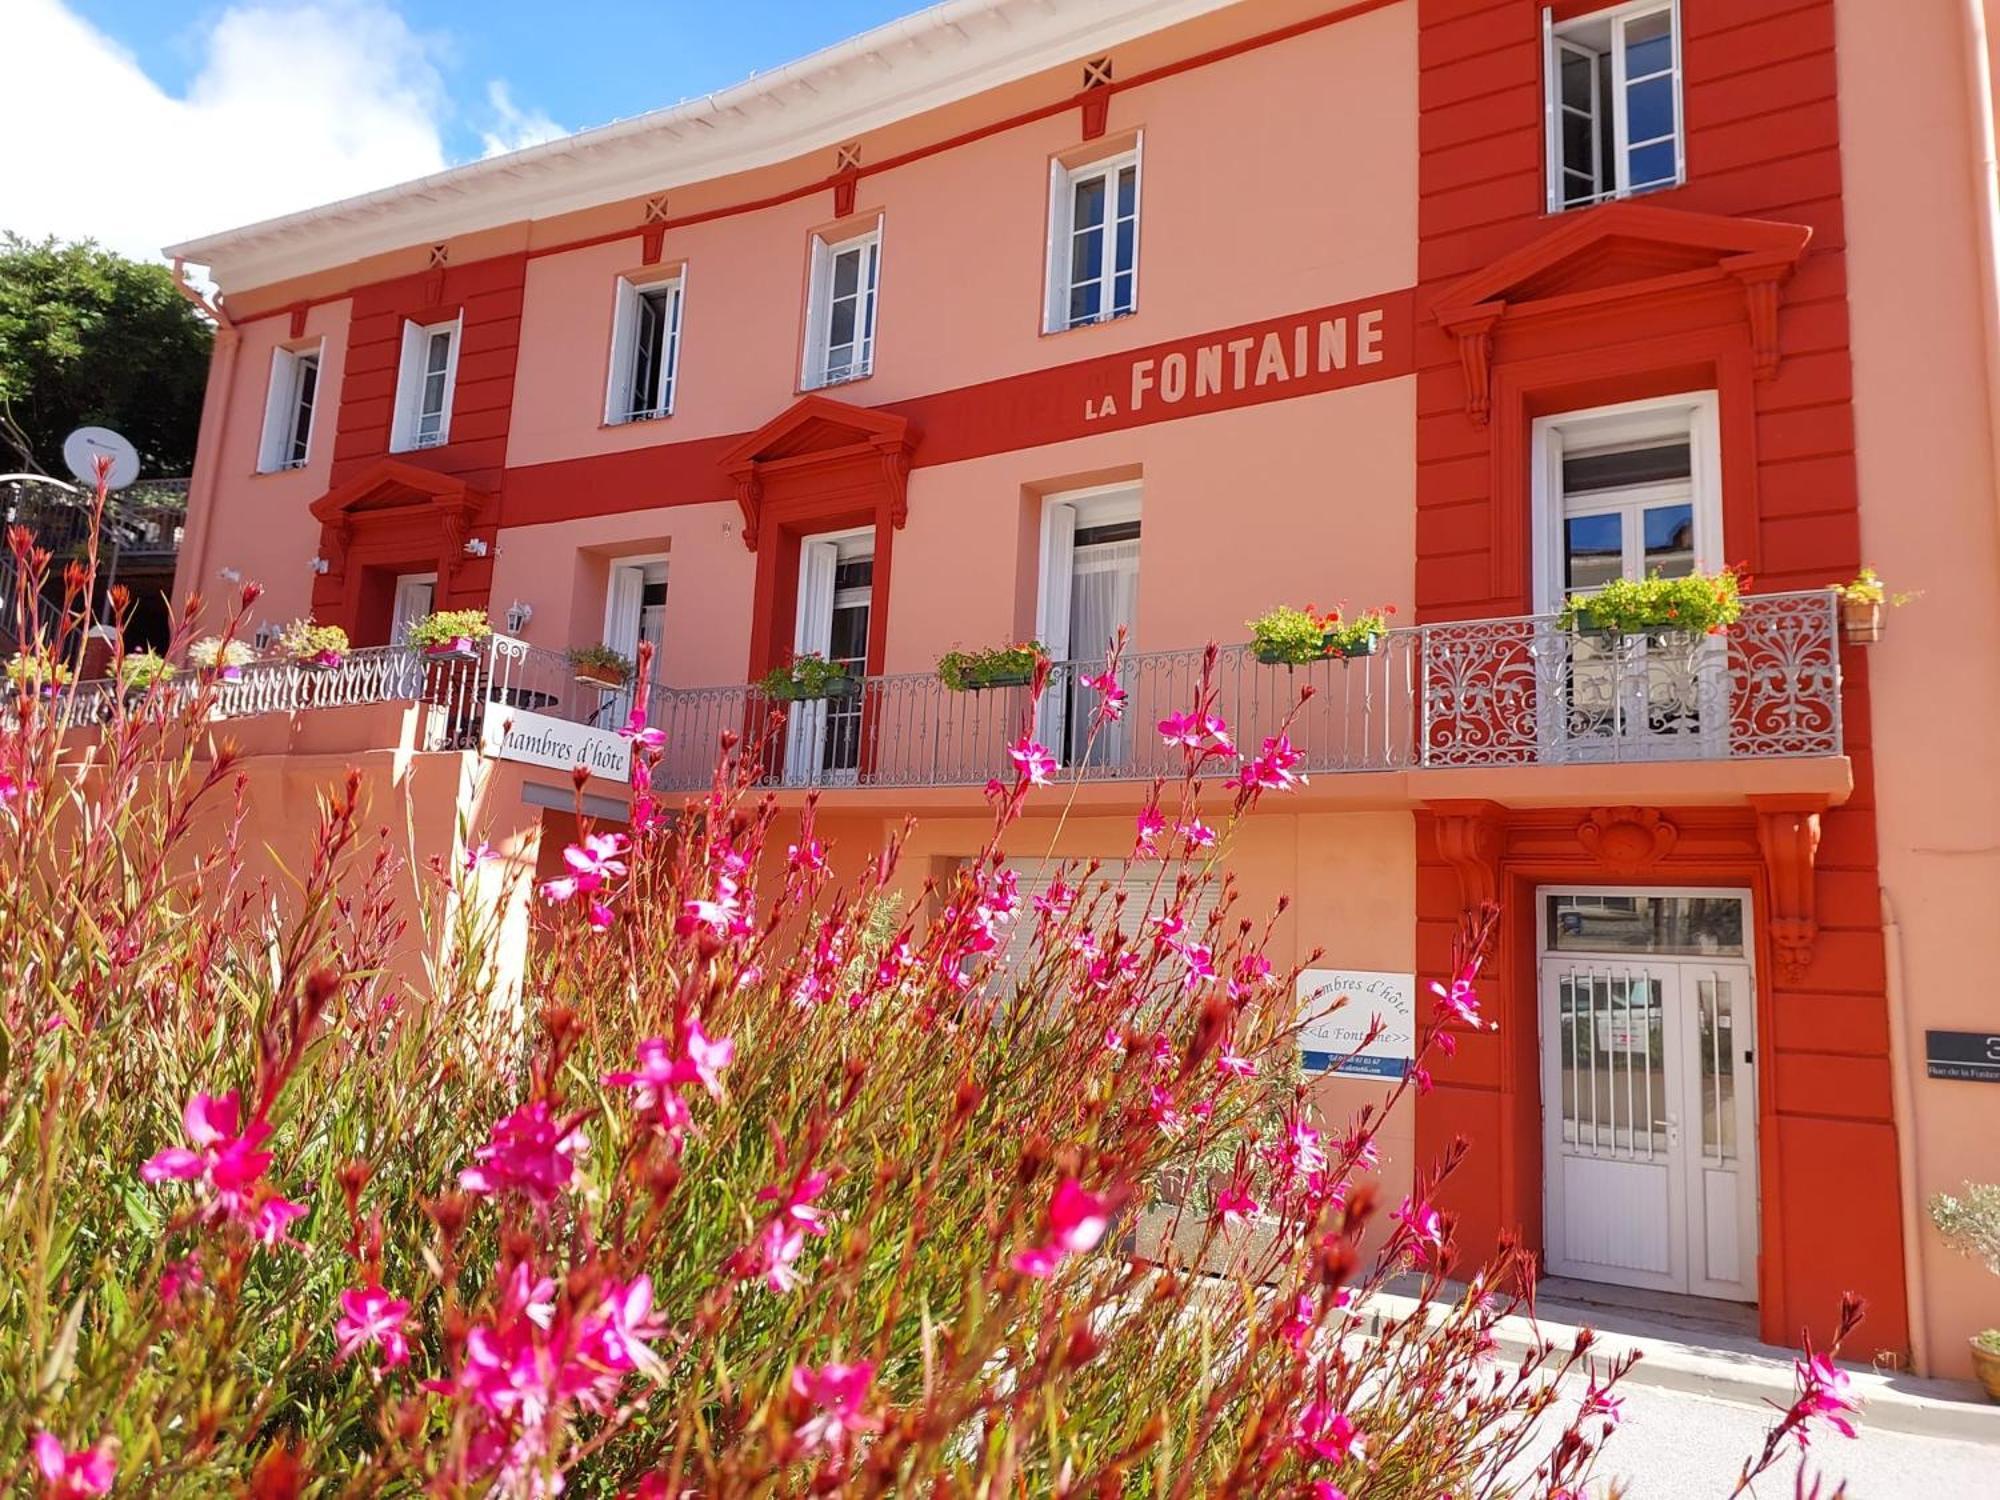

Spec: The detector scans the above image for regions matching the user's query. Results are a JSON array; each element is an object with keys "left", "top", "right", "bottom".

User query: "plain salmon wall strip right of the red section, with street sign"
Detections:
[{"left": 1836, "top": 0, "right": 2000, "bottom": 1374}]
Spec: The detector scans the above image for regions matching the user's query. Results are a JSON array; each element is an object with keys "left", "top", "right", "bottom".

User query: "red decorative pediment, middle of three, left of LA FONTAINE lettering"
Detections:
[{"left": 720, "top": 396, "right": 916, "bottom": 552}]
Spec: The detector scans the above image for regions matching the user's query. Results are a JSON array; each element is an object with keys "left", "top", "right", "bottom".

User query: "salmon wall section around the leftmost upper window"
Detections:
[{"left": 176, "top": 300, "right": 352, "bottom": 624}]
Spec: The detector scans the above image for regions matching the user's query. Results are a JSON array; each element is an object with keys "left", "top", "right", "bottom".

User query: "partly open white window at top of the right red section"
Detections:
[{"left": 1542, "top": 0, "right": 1688, "bottom": 214}]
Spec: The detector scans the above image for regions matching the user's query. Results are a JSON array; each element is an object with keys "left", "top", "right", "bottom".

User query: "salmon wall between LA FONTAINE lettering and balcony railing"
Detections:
[{"left": 886, "top": 378, "right": 1414, "bottom": 672}]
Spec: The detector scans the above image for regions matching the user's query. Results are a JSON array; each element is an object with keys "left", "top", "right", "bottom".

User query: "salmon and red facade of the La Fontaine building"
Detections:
[{"left": 170, "top": 0, "right": 2000, "bottom": 1374}]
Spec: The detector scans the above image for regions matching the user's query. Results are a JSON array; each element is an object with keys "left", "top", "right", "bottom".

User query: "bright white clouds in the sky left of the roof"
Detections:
[{"left": 0, "top": 0, "right": 560, "bottom": 258}]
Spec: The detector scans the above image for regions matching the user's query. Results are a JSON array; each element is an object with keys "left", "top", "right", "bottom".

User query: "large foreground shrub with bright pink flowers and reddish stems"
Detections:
[{"left": 0, "top": 502, "right": 1872, "bottom": 1500}]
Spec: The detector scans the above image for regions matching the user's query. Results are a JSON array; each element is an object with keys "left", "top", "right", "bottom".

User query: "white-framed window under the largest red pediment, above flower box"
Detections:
[{"left": 1534, "top": 392, "right": 1722, "bottom": 612}]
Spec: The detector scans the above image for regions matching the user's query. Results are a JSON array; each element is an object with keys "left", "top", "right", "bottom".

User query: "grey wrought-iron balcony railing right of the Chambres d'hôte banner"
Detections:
[{"left": 650, "top": 592, "right": 1842, "bottom": 790}]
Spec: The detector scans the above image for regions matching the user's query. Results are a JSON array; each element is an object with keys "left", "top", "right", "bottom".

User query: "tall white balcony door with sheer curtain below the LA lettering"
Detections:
[{"left": 1036, "top": 484, "right": 1140, "bottom": 764}]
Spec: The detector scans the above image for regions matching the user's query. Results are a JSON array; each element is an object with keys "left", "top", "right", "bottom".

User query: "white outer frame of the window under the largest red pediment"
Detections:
[{"left": 1530, "top": 390, "right": 1726, "bottom": 614}]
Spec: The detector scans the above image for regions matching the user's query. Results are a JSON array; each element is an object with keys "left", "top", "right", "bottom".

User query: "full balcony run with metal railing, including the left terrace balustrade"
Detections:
[{"left": 39, "top": 590, "right": 1842, "bottom": 796}]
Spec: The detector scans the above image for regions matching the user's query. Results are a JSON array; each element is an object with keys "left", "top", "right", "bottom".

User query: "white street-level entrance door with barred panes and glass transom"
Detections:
[{"left": 1540, "top": 892, "right": 1758, "bottom": 1302}]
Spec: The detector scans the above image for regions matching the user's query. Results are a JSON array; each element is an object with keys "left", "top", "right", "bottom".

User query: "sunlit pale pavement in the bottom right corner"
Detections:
[{"left": 1592, "top": 1384, "right": 2000, "bottom": 1500}]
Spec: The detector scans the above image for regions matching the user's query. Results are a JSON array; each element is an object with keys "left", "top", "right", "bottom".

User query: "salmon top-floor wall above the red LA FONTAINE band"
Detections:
[{"left": 492, "top": 6, "right": 1416, "bottom": 466}]
